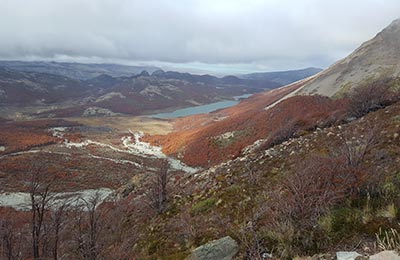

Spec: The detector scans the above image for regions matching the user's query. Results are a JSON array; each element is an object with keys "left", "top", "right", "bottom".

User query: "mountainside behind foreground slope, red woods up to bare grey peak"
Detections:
[{"left": 149, "top": 20, "right": 400, "bottom": 166}]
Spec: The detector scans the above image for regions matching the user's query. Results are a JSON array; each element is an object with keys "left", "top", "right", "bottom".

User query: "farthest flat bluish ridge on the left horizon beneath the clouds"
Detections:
[{"left": 0, "top": 61, "right": 159, "bottom": 80}]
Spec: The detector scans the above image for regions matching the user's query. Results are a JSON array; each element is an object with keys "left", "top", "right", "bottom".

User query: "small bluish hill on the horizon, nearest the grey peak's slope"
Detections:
[{"left": 239, "top": 68, "right": 322, "bottom": 85}]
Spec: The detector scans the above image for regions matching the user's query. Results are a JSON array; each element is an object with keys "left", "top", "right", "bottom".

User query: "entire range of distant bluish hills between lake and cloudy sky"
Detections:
[{"left": 0, "top": 61, "right": 318, "bottom": 118}]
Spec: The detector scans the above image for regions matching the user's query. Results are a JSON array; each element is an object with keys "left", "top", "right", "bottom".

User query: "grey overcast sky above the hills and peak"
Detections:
[{"left": 0, "top": 0, "right": 400, "bottom": 74}]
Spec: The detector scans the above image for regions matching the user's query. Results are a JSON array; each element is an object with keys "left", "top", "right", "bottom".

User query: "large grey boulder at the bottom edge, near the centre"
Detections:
[{"left": 185, "top": 236, "right": 239, "bottom": 260}]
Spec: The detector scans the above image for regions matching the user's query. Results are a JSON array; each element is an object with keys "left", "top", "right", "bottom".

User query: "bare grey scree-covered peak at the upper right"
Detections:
[{"left": 298, "top": 19, "right": 400, "bottom": 96}]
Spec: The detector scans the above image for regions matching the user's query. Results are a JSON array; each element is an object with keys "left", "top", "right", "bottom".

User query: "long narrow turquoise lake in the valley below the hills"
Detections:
[{"left": 150, "top": 94, "right": 253, "bottom": 119}]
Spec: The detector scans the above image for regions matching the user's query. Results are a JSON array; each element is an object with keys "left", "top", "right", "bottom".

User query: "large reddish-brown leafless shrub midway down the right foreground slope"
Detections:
[{"left": 271, "top": 157, "right": 362, "bottom": 229}]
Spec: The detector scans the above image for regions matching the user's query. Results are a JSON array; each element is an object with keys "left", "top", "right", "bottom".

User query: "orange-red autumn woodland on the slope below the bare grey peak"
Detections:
[{"left": 148, "top": 78, "right": 346, "bottom": 166}]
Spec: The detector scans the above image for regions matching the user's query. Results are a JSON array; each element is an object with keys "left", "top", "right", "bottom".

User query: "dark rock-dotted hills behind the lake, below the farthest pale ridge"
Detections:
[{"left": 0, "top": 67, "right": 272, "bottom": 117}]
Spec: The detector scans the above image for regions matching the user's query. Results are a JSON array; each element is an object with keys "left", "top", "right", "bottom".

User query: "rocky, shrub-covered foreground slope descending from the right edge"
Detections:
[{"left": 135, "top": 97, "right": 400, "bottom": 259}]
